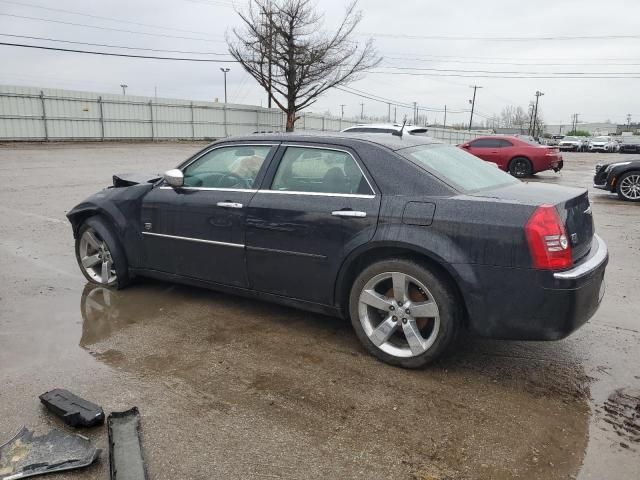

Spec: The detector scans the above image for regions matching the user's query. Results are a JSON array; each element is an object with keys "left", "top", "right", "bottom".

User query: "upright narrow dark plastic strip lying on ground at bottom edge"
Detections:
[{"left": 107, "top": 407, "right": 147, "bottom": 480}]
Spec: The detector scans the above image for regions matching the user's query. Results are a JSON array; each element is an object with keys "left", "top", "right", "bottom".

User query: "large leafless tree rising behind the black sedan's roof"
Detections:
[{"left": 227, "top": 0, "right": 381, "bottom": 132}]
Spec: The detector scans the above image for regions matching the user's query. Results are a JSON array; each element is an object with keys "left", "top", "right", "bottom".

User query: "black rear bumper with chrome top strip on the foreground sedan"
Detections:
[{"left": 458, "top": 235, "right": 609, "bottom": 340}]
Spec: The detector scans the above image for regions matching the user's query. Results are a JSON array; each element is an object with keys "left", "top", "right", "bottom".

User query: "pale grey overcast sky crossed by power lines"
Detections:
[{"left": 0, "top": 0, "right": 640, "bottom": 124}]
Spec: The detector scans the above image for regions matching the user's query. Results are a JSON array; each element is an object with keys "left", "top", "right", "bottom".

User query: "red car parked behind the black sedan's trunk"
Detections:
[{"left": 460, "top": 136, "right": 563, "bottom": 178}]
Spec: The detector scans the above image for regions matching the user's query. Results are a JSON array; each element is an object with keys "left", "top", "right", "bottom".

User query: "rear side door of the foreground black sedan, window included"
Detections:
[{"left": 245, "top": 144, "right": 380, "bottom": 305}]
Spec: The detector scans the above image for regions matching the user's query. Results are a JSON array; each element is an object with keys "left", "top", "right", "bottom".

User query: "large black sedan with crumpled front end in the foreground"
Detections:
[{"left": 68, "top": 134, "right": 608, "bottom": 367}]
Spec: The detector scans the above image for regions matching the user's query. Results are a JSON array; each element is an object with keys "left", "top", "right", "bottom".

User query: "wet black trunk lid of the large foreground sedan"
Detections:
[{"left": 473, "top": 182, "right": 594, "bottom": 263}]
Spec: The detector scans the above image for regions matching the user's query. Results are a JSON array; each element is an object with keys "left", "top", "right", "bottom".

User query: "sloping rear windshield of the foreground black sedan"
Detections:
[{"left": 398, "top": 145, "right": 519, "bottom": 193}]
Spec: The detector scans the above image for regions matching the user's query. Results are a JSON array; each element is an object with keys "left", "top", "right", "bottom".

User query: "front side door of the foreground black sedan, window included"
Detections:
[{"left": 142, "top": 144, "right": 276, "bottom": 287}]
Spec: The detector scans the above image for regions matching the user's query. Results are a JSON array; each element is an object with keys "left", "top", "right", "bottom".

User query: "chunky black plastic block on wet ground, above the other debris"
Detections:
[{"left": 40, "top": 388, "right": 104, "bottom": 427}]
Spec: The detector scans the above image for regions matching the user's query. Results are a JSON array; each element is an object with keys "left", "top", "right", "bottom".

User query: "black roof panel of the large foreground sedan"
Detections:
[{"left": 220, "top": 132, "right": 444, "bottom": 150}]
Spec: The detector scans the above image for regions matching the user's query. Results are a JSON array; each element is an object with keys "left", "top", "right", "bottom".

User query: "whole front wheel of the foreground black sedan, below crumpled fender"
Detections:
[{"left": 75, "top": 215, "right": 129, "bottom": 289}]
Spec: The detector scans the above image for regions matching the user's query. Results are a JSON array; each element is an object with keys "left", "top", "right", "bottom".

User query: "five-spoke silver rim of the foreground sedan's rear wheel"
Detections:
[{"left": 358, "top": 272, "right": 440, "bottom": 358}]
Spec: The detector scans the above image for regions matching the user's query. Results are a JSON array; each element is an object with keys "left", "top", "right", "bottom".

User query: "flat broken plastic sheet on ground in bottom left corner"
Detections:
[{"left": 0, "top": 427, "right": 100, "bottom": 480}]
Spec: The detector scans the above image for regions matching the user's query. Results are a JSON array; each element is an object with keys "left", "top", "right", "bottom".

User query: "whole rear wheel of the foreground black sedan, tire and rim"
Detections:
[{"left": 349, "top": 258, "right": 462, "bottom": 368}]
